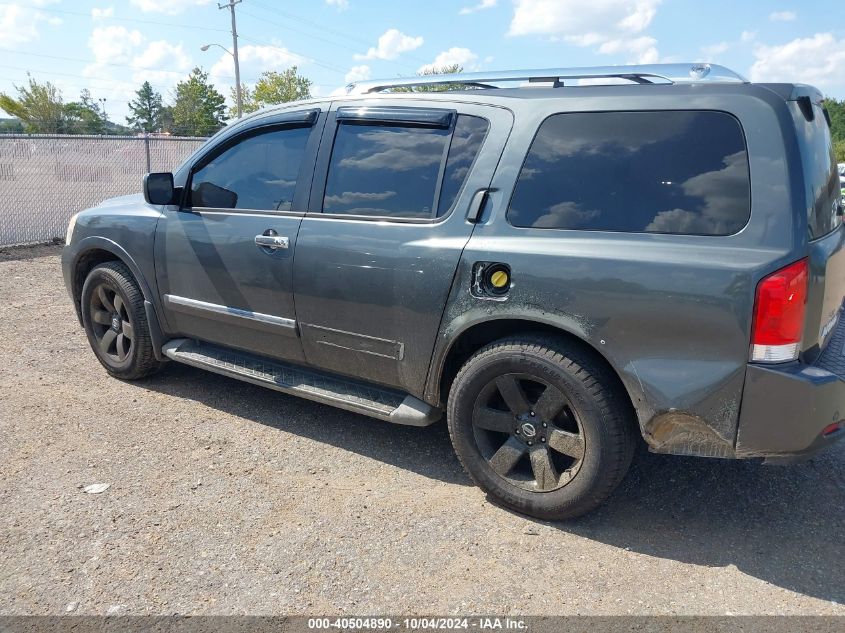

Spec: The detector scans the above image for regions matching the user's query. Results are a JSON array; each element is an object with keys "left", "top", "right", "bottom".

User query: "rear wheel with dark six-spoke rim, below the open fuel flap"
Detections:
[{"left": 448, "top": 336, "right": 636, "bottom": 520}]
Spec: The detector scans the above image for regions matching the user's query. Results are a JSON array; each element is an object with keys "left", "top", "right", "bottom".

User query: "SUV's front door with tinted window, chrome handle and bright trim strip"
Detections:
[{"left": 156, "top": 110, "right": 325, "bottom": 362}]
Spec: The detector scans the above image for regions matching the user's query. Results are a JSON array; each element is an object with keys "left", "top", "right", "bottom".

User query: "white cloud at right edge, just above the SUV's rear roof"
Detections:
[{"left": 749, "top": 33, "right": 845, "bottom": 92}]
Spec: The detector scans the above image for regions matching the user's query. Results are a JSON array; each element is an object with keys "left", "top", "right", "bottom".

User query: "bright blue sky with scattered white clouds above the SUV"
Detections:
[{"left": 0, "top": 0, "right": 845, "bottom": 123}]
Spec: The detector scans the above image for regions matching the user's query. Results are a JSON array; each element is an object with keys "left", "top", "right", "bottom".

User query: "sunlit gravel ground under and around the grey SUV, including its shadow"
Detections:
[{"left": 0, "top": 247, "right": 845, "bottom": 615}]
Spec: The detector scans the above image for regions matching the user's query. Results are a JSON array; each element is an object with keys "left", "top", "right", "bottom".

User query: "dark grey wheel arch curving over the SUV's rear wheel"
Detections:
[{"left": 425, "top": 315, "right": 644, "bottom": 419}]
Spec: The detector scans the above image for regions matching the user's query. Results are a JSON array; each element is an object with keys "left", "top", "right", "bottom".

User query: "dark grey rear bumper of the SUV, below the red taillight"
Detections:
[{"left": 736, "top": 318, "right": 845, "bottom": 463}]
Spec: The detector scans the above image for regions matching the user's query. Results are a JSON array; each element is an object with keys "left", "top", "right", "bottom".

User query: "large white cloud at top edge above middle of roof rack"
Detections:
[{"left": 508, "top": 0, "right": 662, "bottom": 63}]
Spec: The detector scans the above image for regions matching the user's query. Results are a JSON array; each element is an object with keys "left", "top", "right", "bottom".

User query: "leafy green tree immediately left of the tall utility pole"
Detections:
[{"left": 173, "top": 67, "right": 226, "bottom": 136}]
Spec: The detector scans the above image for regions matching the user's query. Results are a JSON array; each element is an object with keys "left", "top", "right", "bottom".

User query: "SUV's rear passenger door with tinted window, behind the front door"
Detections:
[{"left": 294, "top": 99, "right": 512, "bottom": 394}]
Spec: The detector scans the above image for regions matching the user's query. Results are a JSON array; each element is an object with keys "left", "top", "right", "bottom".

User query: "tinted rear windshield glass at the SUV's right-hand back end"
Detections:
[{"left": 790, "top": 101, "right": 842, "bottom": 239}]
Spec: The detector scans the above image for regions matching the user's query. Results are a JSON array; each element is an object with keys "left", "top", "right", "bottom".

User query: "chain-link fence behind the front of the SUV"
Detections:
[{"left": 0, "top": 134, "right": 205, "bottom": 246}]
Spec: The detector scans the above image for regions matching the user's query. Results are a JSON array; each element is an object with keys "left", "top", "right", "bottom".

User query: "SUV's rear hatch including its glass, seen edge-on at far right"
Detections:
[{"left": 789, "top": 86, "right": 845, "bottom": 360}]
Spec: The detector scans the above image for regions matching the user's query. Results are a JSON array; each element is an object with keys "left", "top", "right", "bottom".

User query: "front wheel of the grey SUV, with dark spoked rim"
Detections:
[{"left": 80, "top": 262, "right": 162, "bottom": 380}]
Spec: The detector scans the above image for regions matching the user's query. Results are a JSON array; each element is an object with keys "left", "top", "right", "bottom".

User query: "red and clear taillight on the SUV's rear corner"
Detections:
[{"left": 751, "top": 259, "right": 809, "bottom": 363}]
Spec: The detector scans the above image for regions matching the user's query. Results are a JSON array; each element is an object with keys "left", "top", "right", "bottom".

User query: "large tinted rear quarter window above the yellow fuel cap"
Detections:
[{"left": 507, "top": 111, "right": 751, "bottom": 235}]
